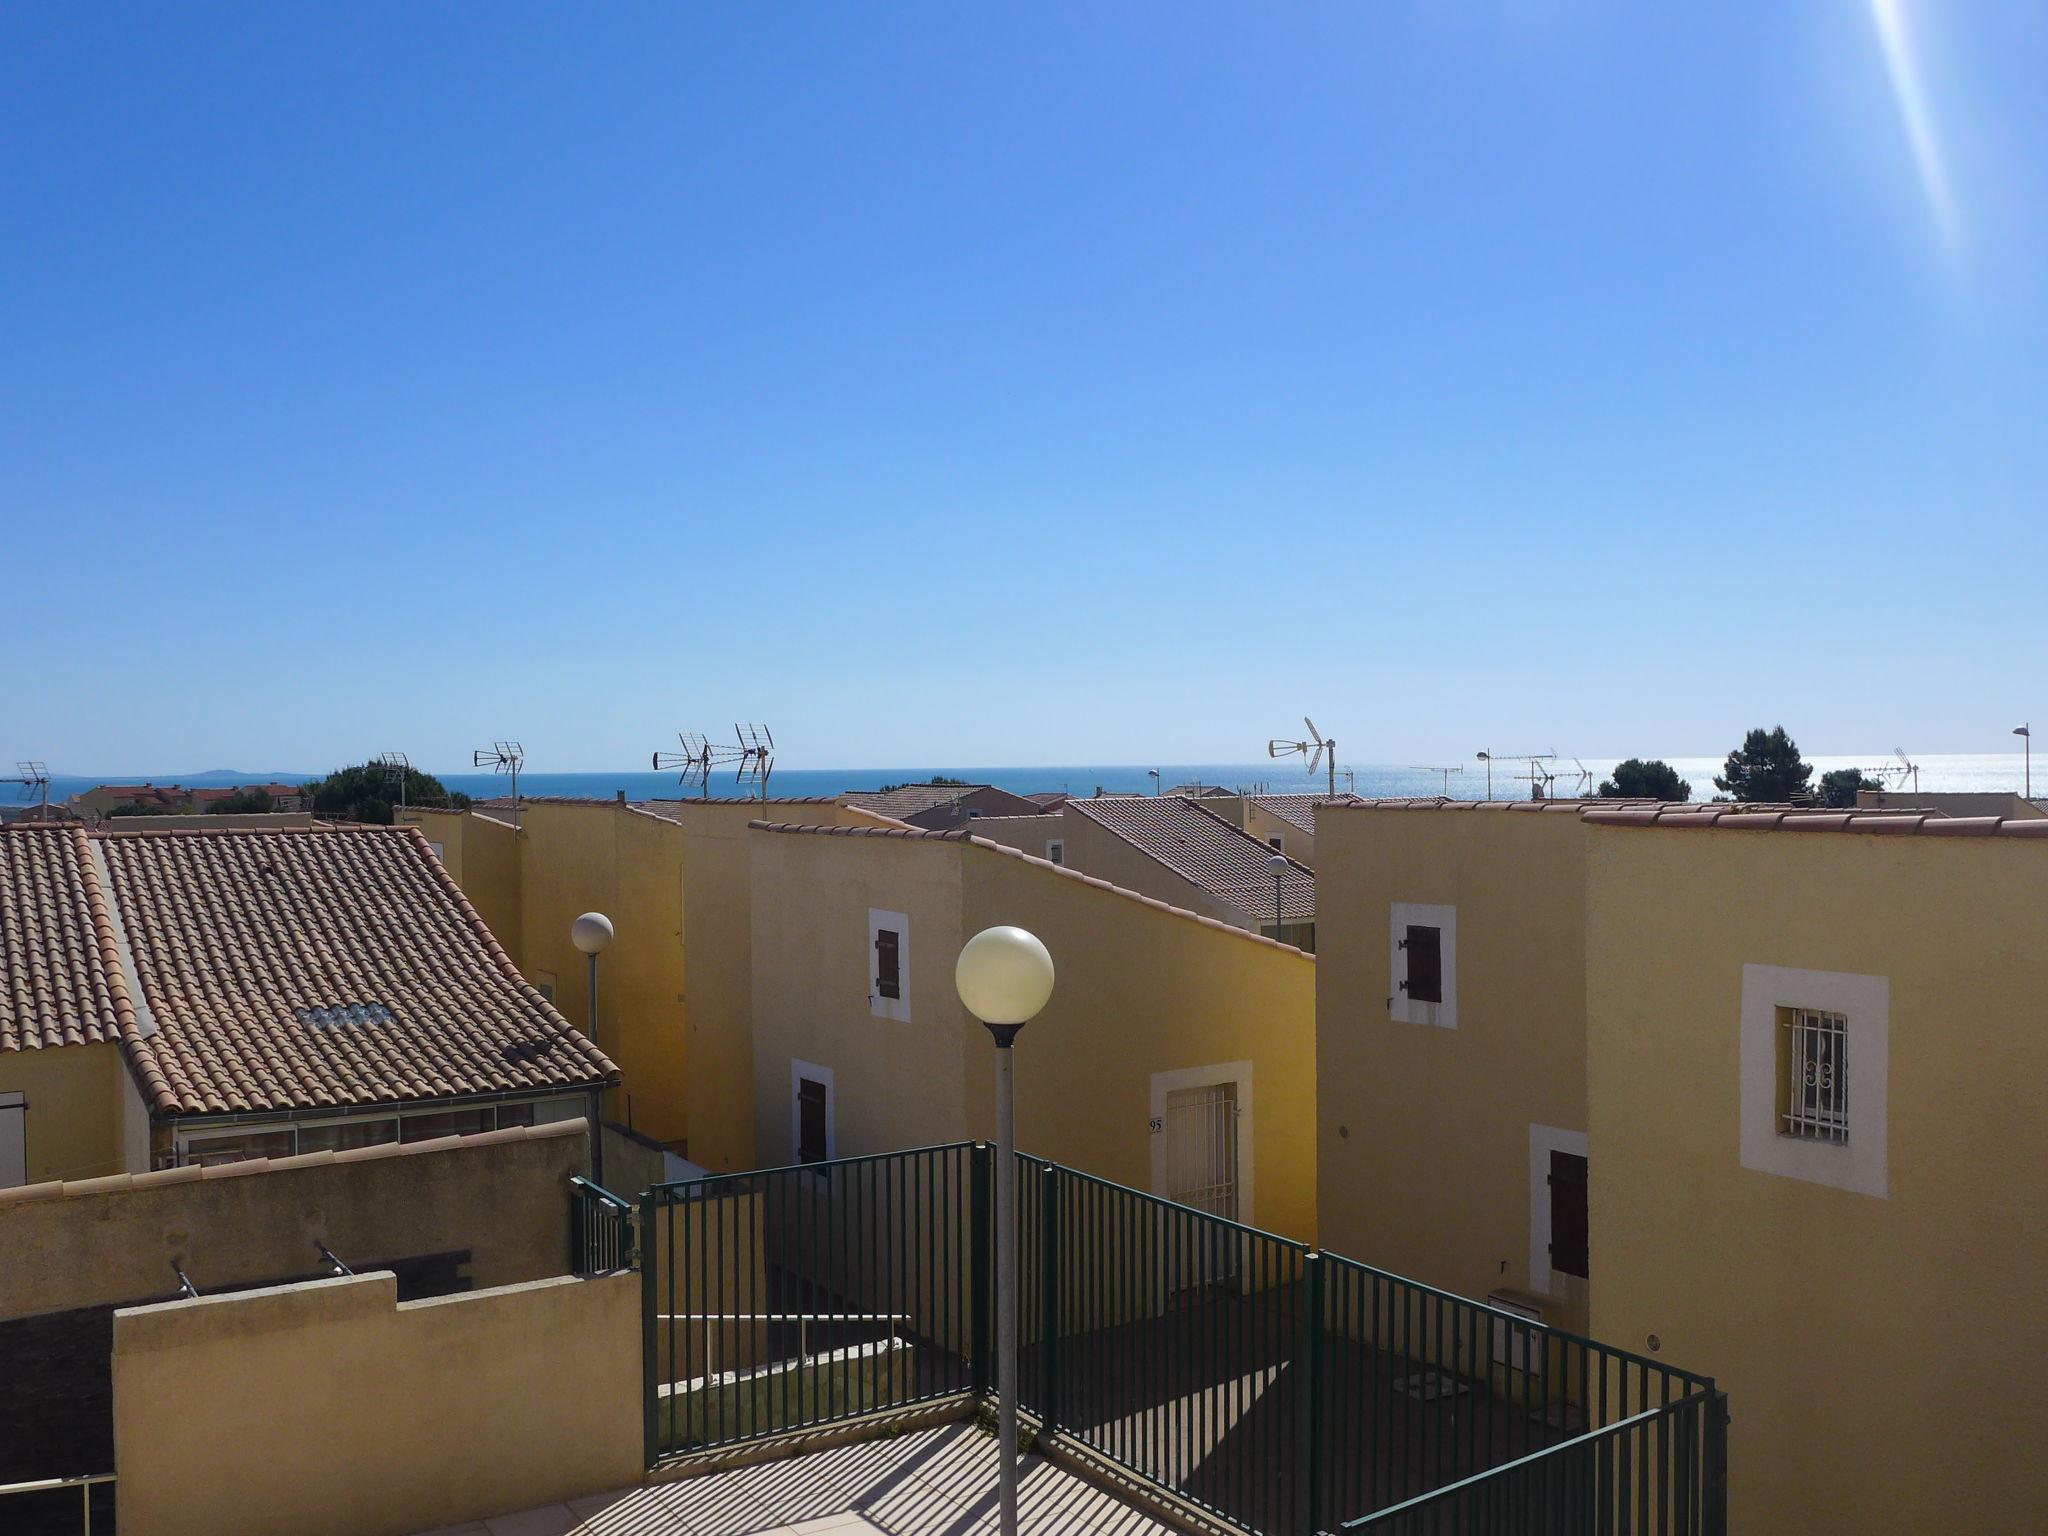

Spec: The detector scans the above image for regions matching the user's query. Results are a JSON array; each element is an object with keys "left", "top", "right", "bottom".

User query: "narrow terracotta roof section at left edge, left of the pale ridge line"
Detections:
[{"left": 0, "top": 823, "right": 133, "bottom": 1051}]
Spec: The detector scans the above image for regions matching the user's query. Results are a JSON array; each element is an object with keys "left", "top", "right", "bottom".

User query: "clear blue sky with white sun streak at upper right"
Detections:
[{"left": 0, "top": 0, "right": 2048, "bottom": 772}]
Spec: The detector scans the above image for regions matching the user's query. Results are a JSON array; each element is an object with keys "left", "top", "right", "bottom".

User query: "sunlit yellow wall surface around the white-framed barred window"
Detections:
[{"left": 1587, "top": 827, "right": 2048, "bottom": 1532}]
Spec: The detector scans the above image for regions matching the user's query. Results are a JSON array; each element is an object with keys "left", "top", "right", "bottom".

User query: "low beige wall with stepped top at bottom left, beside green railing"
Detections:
[{"left": 113, "top": 1274, "right": 643, "bottom": 1536}]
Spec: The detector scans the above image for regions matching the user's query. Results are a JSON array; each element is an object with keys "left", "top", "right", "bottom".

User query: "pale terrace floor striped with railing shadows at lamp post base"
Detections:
[{"left": 415, "top": 1423, "right": 1171, "bottom": 1536}]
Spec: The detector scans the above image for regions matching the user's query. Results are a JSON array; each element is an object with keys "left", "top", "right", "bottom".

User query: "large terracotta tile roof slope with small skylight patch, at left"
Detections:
[{"left": 92, "top": 827, "right": 616, "bottom": 1114}]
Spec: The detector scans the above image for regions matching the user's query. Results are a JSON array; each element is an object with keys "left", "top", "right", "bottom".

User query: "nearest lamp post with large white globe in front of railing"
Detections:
[{"left": 952, "top": 928, "right": 1053, "bottom": 1536}]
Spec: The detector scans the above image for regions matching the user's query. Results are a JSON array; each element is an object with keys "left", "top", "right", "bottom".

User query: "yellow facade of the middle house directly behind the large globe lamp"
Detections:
[{"left": 752, "top": 831, "right": 1317, "bottom": 1239}]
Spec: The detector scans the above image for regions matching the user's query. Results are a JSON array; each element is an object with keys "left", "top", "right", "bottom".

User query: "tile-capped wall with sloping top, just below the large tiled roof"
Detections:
[{"left": 0, "top": 1120, "right": 590, "bottom": 1317}]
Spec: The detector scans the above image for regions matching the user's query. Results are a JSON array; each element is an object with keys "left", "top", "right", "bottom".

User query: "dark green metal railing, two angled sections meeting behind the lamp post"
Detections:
[{"left": 639, "top": 1143, "right": 1726, "bottom": 1536}]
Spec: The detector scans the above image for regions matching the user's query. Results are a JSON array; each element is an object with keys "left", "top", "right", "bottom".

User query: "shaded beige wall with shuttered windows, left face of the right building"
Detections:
[{"left": 1315, "top": 803, "right": 1589, "bottom": 1327}]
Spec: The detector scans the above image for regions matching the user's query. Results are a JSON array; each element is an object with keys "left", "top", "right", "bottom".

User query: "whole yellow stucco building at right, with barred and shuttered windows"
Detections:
[{"left": 1317, "top": 801, "right": 2048, "bottom": 1534}]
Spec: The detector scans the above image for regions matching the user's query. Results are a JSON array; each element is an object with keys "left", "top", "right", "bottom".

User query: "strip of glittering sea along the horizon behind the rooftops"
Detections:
[{"left": 24, "top": 752, "right": 2048, "bottom": 801}]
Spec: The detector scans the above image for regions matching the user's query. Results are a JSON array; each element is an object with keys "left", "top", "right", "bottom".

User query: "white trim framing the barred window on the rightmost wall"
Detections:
[{"left": 1741, "top": 965, "right": 1892, "bottom": 1200}]
